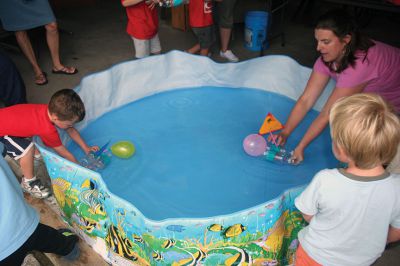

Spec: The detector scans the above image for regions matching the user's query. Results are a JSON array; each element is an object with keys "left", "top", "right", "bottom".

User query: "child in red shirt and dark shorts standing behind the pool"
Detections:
[{"left": 187, "top": 0, "right": 215, "bottom": 56}]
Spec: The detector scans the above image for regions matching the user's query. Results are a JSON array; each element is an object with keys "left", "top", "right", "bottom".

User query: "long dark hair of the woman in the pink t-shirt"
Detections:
[{"left": 315, "top": 9, "right": 375, "bottom": 73}]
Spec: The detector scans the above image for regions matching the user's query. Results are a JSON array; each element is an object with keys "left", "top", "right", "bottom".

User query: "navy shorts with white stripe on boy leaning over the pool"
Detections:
[{"left": 0, "top": 136, "right": 33, "bottom": 160}]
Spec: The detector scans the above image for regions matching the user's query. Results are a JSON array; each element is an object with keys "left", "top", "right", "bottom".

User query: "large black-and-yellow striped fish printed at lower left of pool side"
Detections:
[{"left": 105, "top": 225, "right": 138, "bottom": 261}]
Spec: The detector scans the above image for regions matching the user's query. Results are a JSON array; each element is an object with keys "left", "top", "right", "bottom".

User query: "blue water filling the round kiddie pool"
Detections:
[{"left": 69, "top": 87, "right": 337, "bottom": 220}]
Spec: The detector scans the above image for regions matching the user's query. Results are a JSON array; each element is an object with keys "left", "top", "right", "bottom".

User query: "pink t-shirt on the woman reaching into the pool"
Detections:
[{"left": 314, "top": 41, "right": 400, "bottom": 113}]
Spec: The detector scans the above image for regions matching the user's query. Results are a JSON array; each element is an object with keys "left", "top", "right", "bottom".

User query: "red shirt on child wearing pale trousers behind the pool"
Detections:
[{"left": 121, "top": 0, "right": 158, "bottom": 40}]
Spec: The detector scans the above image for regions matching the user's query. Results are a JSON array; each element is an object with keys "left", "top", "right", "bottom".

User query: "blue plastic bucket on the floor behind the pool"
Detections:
[{"left": 244, "top": 11, "right": 269, "bottom": 51}]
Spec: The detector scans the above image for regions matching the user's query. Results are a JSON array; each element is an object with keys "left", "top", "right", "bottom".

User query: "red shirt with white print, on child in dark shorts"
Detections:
[{"left": 189, "top": 0, "right": 213, "bottom": 28}]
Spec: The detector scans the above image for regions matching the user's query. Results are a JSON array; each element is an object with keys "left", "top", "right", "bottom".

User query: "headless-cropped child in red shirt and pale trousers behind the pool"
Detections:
[{"left": 121, "top": 0, "right": 161, "bottom": 58}]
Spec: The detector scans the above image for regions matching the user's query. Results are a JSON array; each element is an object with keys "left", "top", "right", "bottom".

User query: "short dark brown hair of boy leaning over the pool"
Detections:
[{"left": 48, "top": 89, "right": 85, "bottom": 122}]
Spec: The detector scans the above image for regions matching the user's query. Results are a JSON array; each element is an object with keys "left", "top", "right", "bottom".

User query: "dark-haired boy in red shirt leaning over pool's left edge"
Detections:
[{"left": 0, "top": 89, "right": 99, "bottom": 198}]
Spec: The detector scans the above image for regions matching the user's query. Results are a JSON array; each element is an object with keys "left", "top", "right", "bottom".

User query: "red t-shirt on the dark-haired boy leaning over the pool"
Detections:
[{"left": 0, "top": 104, "right": 62, "bottom": 148}]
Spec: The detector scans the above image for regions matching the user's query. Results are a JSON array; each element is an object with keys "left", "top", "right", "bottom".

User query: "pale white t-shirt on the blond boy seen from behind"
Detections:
[{"left": 295, "top": 169, "right": 400, "bottom": 266}]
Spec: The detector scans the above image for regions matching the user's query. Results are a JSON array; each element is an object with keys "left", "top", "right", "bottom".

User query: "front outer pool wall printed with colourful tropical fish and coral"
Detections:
[{"left": 41, "top": 147, "right": 306, "bottom": 265}]
